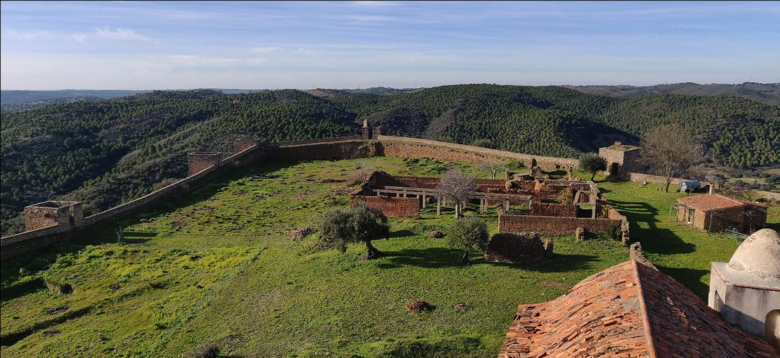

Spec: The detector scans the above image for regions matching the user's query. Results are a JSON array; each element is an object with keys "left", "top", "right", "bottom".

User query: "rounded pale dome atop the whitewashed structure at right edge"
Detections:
[{"left": 729, "top": 229, "right": 780, "bottom": 278}]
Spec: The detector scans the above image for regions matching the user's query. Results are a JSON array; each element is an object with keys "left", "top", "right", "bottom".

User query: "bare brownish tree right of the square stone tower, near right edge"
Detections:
[{"left": 641, "top": 124, "right": 704, "bottom": 193}]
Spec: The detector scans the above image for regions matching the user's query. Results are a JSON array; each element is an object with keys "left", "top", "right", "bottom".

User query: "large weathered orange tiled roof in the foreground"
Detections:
[{"left": 498, "top": 260, "right": 776, "bottom": 358}]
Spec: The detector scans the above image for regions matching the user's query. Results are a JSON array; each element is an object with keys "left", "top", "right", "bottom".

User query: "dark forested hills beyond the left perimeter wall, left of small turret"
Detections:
[{"left": 0, "top": 90, "right": 359, "bottom": 235}]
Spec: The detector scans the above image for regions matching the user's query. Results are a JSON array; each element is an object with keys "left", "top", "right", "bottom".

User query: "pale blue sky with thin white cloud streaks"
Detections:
[{"left": 0, "top": 1, "right": 780, "bottom": 90}]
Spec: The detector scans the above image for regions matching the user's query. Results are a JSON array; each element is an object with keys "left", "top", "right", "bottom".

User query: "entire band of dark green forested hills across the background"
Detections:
[{"left": 0, "top": 85, "right": 780, "bottom": 234}]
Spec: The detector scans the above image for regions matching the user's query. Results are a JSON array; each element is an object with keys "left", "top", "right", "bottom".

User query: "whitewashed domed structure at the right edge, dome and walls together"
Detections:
[{"left": 707, "top": 229, "right": 780, "bottom": 347}]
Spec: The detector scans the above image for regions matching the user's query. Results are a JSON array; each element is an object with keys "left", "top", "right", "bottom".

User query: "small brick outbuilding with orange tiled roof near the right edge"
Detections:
[{"left": 677, "top": 194, "right": 767, "bottom": 233}]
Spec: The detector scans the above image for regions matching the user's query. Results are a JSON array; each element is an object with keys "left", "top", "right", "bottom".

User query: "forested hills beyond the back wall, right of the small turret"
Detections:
[{"left": 329, "top": 85, "right": 780, "bottom": 167}]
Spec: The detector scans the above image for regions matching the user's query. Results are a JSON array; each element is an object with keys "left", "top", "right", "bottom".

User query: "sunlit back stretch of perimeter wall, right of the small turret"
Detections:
[{"left": 377, "top": 135, "right": 579, "bottom": 170}]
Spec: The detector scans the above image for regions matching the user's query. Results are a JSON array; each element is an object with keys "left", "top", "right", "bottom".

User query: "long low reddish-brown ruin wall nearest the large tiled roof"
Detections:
[{"left": 498, "top": 212, "right": 621, "bottom": 236}]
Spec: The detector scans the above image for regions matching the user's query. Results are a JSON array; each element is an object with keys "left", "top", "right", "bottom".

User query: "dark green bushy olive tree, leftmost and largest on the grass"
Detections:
[{"left": 319, "top": 202, "right": 390, "bottom": 260}]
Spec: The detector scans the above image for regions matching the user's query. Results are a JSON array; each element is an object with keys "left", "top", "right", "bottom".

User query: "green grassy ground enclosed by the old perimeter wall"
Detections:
[{"left": 0, "top": 158, "right": 780, "bottom": 357}]
